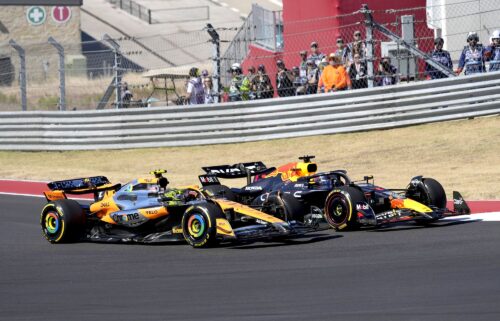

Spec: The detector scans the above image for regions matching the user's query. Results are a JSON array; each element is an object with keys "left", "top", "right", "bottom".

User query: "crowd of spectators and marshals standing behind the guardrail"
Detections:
[{"left": 182, "top": 30, "right": 500, "bottom": 104}]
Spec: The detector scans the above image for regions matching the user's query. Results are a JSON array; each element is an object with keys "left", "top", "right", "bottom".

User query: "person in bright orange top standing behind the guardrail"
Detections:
[{"left": 318, "top": 53, "right": 351, "bottom": 93}]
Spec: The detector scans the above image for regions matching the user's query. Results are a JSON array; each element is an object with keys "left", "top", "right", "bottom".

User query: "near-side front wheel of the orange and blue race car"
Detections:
[{"left": 181, "top": 203, "right": 224, "bottom": 248}]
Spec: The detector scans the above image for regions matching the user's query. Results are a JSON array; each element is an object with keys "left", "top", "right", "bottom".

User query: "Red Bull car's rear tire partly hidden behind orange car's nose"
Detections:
[{"left": 262, "top": 193, "right": 306, "bottom": 222}]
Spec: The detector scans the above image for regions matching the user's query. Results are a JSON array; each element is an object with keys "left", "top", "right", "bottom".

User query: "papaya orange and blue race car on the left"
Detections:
[{"left": 40, "top": 170, "right": 318, "bottom": 247}]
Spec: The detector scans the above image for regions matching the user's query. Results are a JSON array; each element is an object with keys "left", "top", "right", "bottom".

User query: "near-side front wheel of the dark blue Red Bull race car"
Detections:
[{"left": 325, "top": 186, "right": 366, "bottom": 231}]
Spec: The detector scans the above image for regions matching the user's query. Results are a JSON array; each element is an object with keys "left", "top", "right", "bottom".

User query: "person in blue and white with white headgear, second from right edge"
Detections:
[{"left": 456, "top": 32, "right": 486, "bottom": 75}]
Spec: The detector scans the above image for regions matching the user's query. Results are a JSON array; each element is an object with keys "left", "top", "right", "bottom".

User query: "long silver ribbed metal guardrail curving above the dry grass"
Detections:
[{"left": 0, "top": 72, "right": 500, "bottom": 150}]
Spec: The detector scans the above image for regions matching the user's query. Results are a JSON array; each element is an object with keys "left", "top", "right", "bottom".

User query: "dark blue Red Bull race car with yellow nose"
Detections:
[{"left": 198, "top": 156, "right": 470, "bottom": 230}]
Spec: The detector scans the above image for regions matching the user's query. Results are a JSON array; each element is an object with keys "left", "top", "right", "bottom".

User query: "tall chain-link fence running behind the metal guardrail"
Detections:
[{"left": 0, "top": 0, "right": 500, "bottom": 111}]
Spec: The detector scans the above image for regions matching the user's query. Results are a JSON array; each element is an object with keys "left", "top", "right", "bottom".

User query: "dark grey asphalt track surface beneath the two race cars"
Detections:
[{"left": 0, "top": 195, "right": 500, "bottom": 321}]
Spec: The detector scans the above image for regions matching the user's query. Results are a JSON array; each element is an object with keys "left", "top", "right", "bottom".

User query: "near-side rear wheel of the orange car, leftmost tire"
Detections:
[{"left": 40, "top": 199, "right": 86, "bottom": 243}]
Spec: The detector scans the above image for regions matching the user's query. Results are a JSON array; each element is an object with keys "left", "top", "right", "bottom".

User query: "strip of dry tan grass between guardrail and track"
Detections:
[{"left": 0, "top": 116, "right": 500, "bottom": 199}]
